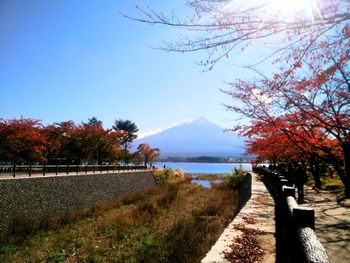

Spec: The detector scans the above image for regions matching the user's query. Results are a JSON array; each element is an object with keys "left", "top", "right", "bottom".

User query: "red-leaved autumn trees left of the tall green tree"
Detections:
[{"left": 0, "top": 118, "right": 128, "bottom": 164}]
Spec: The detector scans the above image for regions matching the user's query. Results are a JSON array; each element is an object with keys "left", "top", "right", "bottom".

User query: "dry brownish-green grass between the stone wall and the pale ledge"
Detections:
[{"left": 0, "top": 174, "right": 238, "bottom": 262}]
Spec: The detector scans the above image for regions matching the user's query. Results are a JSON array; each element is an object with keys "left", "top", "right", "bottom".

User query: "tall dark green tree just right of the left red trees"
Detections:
[{"left": 112, "top": 119, "right": 139, "bottom": 163}]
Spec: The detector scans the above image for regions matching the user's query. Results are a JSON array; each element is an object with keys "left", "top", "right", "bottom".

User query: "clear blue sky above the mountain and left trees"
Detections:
[{"left": 0, "top": 0, "right": 262, "bottom": 136}]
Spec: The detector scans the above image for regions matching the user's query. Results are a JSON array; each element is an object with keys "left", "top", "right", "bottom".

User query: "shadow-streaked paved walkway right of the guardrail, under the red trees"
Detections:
[{"left": 301, "top": 187, "right": 350, "bottom": 263}]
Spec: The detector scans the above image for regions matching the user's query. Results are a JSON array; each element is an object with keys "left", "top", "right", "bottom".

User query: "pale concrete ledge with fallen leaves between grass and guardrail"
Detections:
[{"left": 202, "top": 173, "right": 276, "bottom": 263}]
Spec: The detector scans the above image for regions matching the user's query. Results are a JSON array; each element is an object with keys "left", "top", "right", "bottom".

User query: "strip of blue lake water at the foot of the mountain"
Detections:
[{"left": 155, "top": 162, "right": 252, "bottom": 174}]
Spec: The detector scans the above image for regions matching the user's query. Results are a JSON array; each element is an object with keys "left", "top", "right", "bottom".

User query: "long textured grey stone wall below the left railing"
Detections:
[{"left": 0, "top": 171, "right": 155, "bottom": 232}]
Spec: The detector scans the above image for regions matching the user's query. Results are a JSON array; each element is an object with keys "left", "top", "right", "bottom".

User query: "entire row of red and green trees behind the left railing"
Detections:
[{"left": 0, "top": 117, "right": 159, "bottom": 165}]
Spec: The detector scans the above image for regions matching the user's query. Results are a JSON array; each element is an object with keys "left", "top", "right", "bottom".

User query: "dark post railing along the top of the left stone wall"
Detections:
[{"left": 0, "top": 164, "right": 147, "bottom": 178}]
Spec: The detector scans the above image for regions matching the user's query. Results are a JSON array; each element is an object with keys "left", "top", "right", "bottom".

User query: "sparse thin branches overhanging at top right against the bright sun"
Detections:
[{"left": 129, "top": 0, "right": 350, "bottom": 67}]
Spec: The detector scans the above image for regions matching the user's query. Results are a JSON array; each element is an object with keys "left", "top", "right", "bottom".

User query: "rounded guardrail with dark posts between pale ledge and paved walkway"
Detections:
[{"left": 253, "top": 167, "right": 331, "bottom": 263}]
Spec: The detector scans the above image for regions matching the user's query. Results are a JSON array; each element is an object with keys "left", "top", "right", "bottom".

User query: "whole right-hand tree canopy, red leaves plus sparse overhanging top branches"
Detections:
[{"left": 132, "top": 0, "right": 350, "bottom": 196}]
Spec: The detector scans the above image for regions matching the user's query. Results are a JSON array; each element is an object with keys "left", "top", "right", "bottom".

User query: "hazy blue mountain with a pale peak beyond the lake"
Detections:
[{"left": 133, "top": 117, "right": 245, "bottom": 158}]
